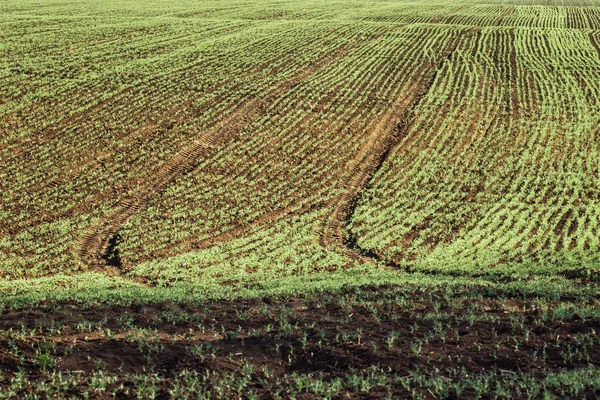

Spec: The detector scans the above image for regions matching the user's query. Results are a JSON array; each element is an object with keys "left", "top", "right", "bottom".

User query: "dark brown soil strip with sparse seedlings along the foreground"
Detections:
[{"left": 0, "top": 287, "right": 600, "bottom": 398}]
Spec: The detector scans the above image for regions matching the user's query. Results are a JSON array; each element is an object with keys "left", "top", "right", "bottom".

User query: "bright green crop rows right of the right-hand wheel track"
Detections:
[{"left": 352, "top": 27, "right": 600, "bottom": 277}]
